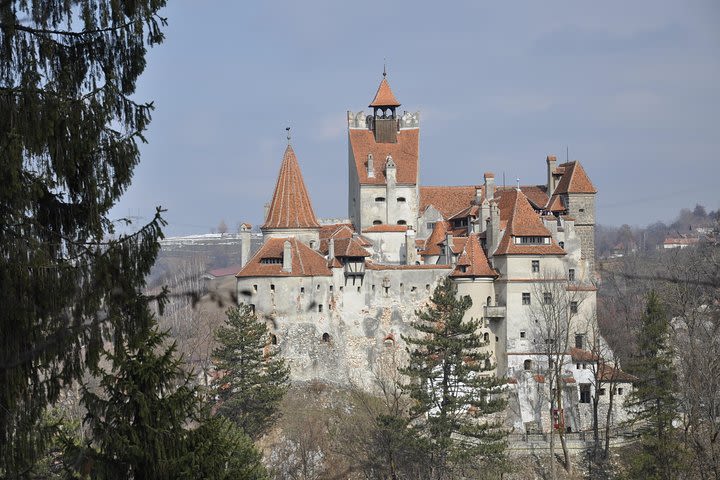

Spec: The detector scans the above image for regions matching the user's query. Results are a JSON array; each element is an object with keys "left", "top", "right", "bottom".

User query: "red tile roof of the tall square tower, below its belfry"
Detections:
[{"left": 348, "top": 128, "right": 419, "bottom": 185}]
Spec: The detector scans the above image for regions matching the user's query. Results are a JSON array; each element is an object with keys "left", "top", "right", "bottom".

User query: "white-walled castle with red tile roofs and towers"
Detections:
[{"left": 236, "top": 74, "right": 632, "bottom": 428}]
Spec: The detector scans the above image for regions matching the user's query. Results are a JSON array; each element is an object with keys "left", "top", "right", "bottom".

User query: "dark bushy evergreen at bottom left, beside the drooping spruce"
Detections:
[{"left": 65, "top": 314, "right": 266, "bottom": 480}]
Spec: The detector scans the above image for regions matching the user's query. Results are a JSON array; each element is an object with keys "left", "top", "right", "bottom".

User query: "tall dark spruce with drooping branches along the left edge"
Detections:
[{"left": 0, "top": 0, "right": 165, "bottom": 476}]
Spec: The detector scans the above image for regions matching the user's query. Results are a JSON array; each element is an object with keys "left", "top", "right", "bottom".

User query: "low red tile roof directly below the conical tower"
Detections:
[{"left": 235, "top": 237, "right": 331, "bottom": 278}]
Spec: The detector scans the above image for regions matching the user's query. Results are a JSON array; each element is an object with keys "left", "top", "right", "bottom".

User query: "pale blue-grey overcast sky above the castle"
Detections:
[{"left": 113, "top": 0, "right": 720, "bottom": 235}]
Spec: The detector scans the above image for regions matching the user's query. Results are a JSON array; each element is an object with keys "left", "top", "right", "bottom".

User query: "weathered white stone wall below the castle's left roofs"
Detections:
[{"left": 237, "top": 268, "right": 450, "bottom": 385}]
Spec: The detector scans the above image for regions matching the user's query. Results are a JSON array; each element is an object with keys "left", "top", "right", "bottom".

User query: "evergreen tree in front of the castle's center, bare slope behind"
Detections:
[{"left": 402, "top": 278, "right": 505, "bottom": 479}]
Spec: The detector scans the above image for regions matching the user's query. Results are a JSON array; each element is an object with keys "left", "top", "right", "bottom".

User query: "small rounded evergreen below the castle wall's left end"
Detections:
[{"left": 213, "top": 305, "right": 290, "bottom": 439}]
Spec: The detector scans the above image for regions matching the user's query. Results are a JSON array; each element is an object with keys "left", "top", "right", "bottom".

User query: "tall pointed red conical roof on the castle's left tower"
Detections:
[{"left": 262, "top": 145, "right": 320, "bottom": 229}]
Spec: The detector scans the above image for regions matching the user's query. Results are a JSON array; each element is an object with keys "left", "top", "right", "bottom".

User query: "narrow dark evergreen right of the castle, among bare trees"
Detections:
[{"left": 626, "top": 291, "right": 681, "bottom": 480}]
